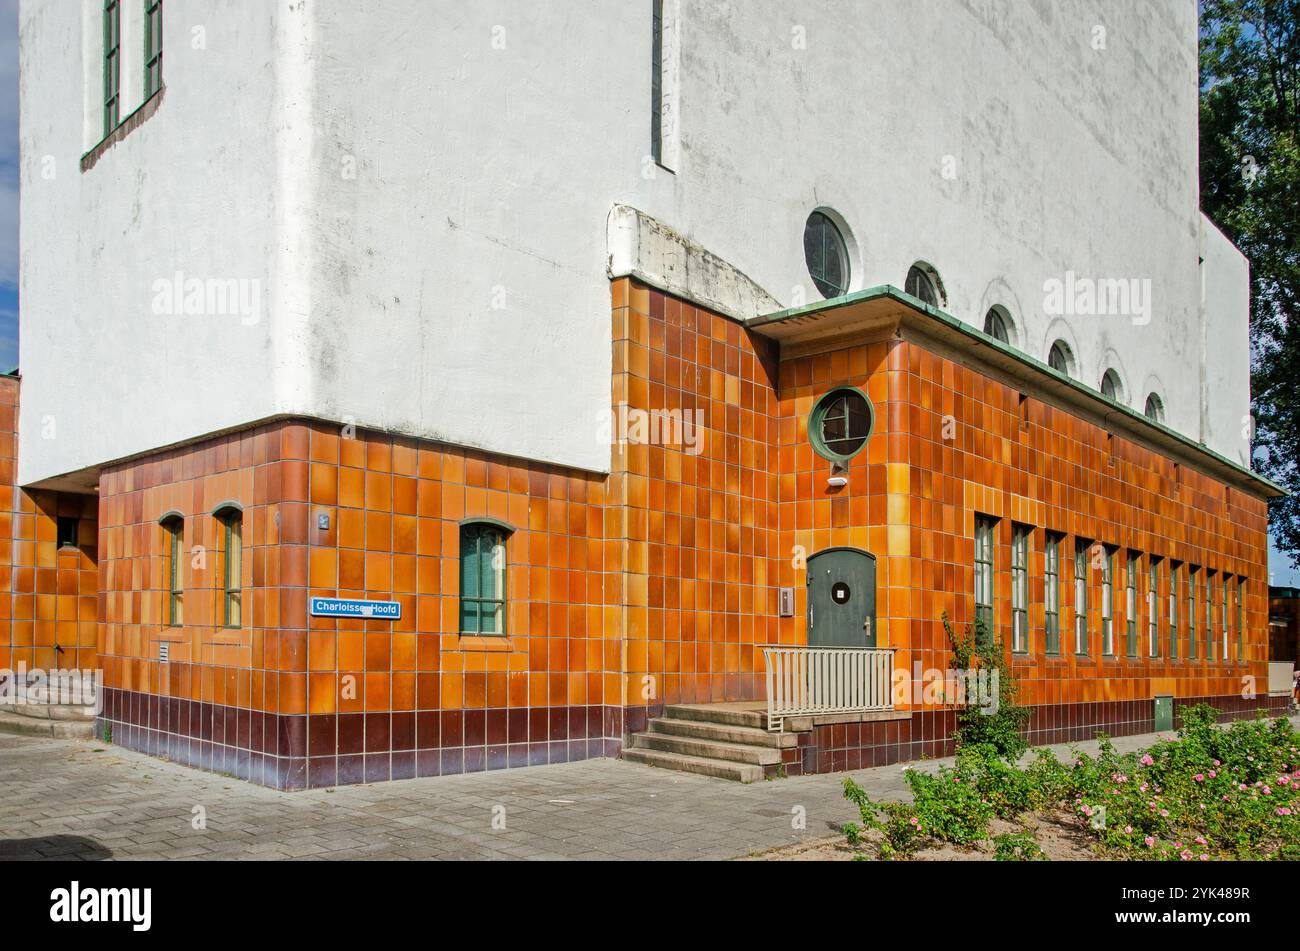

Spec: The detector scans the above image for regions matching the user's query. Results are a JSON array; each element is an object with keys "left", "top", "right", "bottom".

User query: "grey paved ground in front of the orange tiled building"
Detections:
[{"left": 0, "top": 735, "right": 1279, "bottom": 860}]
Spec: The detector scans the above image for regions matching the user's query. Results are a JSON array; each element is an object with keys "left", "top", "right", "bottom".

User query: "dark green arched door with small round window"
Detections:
[{"left": 807, "top": 548, "right": 876, "bottom": 647}]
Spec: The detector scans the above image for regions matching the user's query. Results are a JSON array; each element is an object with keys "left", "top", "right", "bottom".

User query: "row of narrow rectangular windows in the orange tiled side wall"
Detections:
[{"left": 975, "top": 516, "right": 1247, "bottom": 663}]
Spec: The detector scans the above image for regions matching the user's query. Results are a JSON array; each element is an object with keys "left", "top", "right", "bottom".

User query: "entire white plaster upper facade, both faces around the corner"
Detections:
[{"left": 12, "top": 0, "right": 1249, "bottom": 485}]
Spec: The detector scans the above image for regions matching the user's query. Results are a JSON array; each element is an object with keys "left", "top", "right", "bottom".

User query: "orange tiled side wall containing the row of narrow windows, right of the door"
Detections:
[{"left": 894, "top": 343, "right": 1268, "bottom": 704}]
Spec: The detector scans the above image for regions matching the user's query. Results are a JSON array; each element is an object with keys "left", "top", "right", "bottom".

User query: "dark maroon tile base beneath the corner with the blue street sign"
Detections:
[{"left": 98, "top": 689, "right": 658, "bottom": 790}]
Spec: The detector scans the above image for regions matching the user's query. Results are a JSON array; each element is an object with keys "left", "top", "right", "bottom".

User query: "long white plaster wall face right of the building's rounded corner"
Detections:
[{"left": 306, "top": 0, "right": 1247, "bottom": 468}]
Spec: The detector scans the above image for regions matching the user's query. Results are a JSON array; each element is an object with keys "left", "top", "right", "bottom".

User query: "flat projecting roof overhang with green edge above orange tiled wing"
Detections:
[{"left": 746, "top": 286, "right": 1288, "bottom": 499}]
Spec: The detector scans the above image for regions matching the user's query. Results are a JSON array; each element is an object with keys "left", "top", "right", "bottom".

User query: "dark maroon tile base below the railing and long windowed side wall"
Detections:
[{"left": 767, "top": 696, "right": 1290, "bottom": 776}]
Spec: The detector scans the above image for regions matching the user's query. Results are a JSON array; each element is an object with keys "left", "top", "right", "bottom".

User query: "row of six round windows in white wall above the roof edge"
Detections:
[{"left": 803, "top": 210, "right": 1165, "bottom": 422}]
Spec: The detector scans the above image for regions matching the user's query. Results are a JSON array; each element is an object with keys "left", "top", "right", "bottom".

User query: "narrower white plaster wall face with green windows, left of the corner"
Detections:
[{"left": 18, "top": 0, "right": 300, "bottom": 483}]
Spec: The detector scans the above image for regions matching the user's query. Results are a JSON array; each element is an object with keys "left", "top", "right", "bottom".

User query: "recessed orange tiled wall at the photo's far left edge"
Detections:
[{"left": 0, "top": 377, "right": 99, "bottom": 672}]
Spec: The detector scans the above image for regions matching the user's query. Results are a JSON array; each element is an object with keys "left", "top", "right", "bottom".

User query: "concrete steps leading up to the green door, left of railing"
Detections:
[{"left": 623, "top": 704, "right": 798, "bottom": 783}]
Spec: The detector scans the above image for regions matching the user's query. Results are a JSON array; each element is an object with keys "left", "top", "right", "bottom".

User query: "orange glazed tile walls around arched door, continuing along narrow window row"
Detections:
[{"left": 611, "top": 281, "right": 1268, "bottom": 705}]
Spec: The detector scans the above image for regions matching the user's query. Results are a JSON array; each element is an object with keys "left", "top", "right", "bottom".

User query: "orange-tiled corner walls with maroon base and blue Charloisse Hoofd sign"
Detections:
[{"left": 94, "top": 422, "right": 623, "bottom": 786}]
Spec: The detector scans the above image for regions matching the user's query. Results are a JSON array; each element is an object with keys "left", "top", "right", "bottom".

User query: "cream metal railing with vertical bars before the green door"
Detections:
[{"left": 763, "top": 647, "right": 894, "bottom": 733}]
